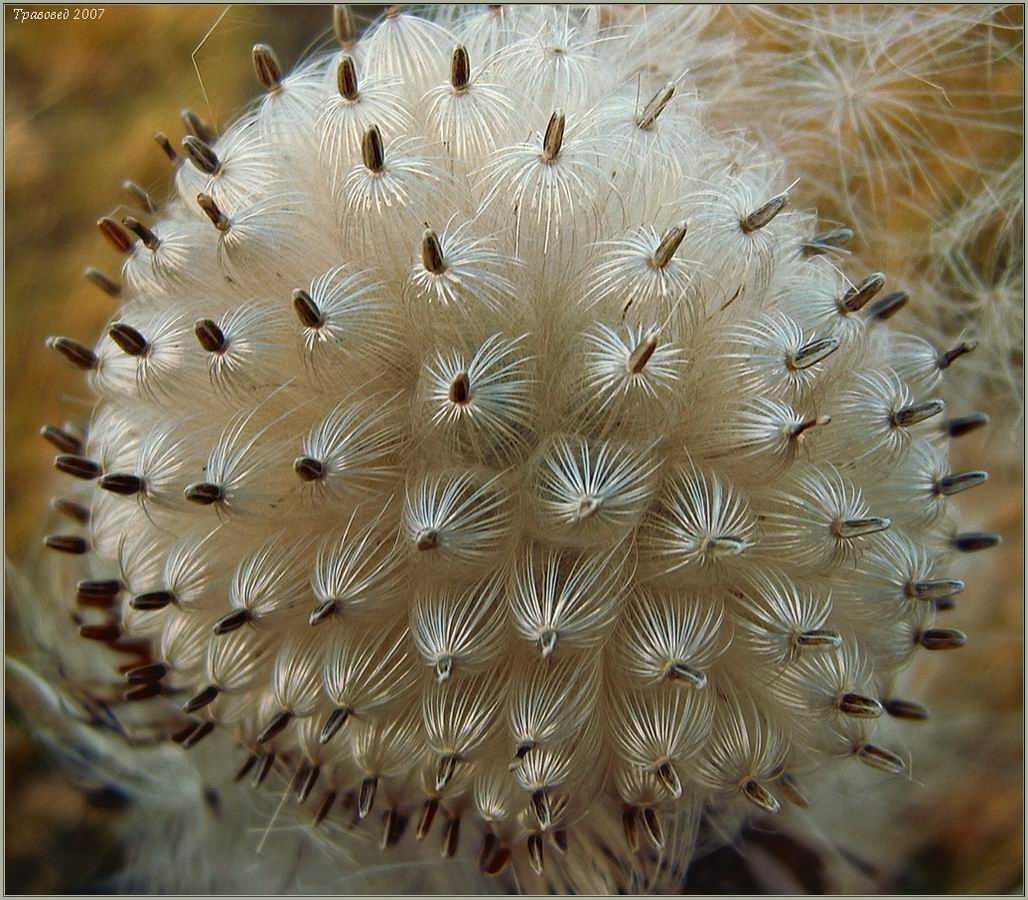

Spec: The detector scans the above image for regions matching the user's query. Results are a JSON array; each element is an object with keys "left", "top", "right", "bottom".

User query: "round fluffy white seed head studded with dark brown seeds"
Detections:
[{"left": 43, "top": 7, "right": 997, "bottom": 892}]
